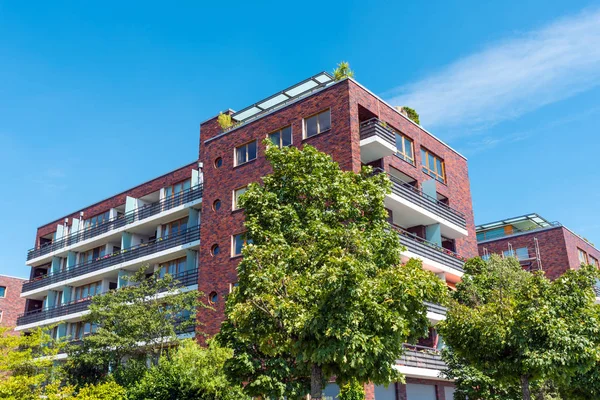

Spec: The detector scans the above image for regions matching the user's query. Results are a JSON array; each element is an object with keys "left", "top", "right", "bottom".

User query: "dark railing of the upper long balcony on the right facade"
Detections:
[{"left": 373, "top": 168, "right": 467, "bottom": 229}]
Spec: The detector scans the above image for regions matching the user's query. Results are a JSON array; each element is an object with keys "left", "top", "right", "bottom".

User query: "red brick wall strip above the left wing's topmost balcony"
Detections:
[{"left": 35, "top": 161, "right": 198, "bottom": 246}]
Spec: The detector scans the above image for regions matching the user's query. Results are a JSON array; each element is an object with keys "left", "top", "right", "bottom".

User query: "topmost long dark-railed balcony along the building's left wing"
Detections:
[{"left": 27, "top": 184, "right": 203, "bottom": 261}]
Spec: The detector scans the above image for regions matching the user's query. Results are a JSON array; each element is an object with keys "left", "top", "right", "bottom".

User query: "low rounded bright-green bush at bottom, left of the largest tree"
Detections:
[{"left": 128, "top": 340, "right": 247, "bottom": 400}]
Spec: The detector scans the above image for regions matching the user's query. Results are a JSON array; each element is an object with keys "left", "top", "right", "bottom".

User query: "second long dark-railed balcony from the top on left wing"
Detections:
[{"left": 22, "top": 226, "right": 200, "bottom": 293}]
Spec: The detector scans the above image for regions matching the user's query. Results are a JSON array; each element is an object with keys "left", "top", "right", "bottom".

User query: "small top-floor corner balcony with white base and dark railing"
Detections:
[{"left": 360, "top": 118, "right": 396, "bottom": 164}]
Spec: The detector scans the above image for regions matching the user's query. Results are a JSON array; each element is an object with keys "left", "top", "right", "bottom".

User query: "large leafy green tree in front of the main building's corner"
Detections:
[{"left": 219, "top": 142, "right": 445, "bottom": 399}]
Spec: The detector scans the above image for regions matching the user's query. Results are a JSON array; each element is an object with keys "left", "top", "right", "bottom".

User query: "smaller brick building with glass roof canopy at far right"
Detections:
[{"left": 476, "top": 214, "right": 600, "bottom": 279}]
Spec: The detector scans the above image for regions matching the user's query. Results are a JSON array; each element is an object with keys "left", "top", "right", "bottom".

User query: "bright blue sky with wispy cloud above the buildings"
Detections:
[{"left": 0, "top": 0, "right": 600, "bottom": 276}]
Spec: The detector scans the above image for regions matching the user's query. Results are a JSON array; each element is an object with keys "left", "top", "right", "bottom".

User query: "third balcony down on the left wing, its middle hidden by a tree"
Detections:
[{"left": 17, "top": 269, "right": 198, "bottom": 326}]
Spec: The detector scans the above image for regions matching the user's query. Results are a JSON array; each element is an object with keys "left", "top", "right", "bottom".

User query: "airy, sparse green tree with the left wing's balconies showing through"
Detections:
[{"left": 66, "top": 268, "right": 202, "bottom": 386}]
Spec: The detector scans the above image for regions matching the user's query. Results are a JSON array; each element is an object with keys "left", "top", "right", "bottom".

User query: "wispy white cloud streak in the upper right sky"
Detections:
[{"left": 387, "top": 9, "right": 600, "bottom": 132}]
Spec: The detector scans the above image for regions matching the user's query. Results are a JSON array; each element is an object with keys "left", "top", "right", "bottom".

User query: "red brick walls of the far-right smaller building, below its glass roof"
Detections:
[{"left": 478, "top": 226, "right": 600, "bottom": 279}]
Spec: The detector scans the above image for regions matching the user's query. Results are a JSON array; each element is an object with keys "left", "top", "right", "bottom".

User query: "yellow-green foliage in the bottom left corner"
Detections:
[{"left": 0, "top": 328, "right": 62, "bottom": 400}]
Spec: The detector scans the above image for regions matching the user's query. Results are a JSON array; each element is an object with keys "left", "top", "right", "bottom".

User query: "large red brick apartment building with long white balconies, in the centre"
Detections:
[{"left": 18, "top": 73, "right": 477, "bottom": 400}]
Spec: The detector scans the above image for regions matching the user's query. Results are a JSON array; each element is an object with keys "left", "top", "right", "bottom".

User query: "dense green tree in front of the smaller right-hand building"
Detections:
[{"left": 438, "top": 256, "right": 600, "bottom": 400}]
